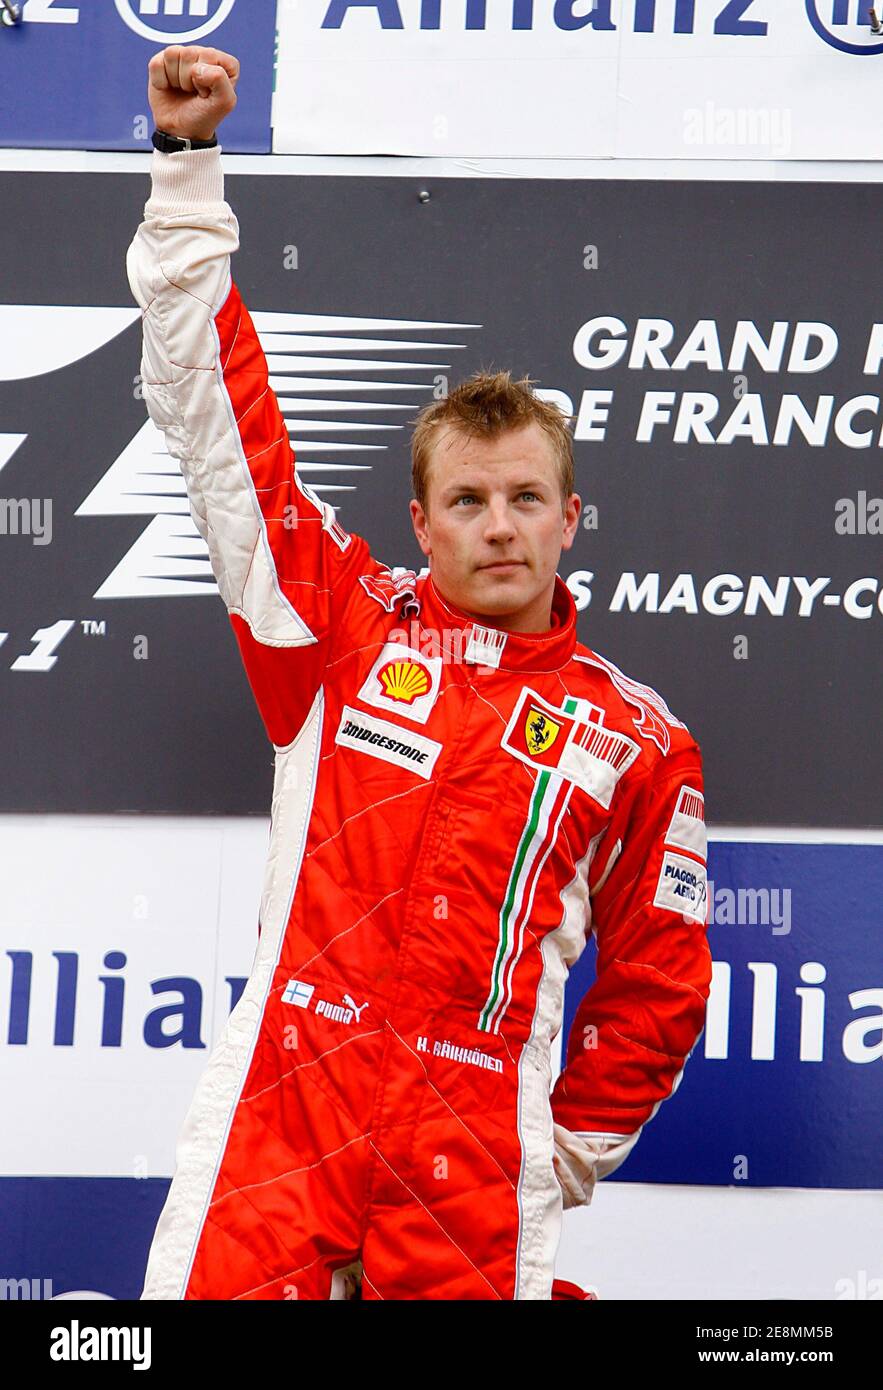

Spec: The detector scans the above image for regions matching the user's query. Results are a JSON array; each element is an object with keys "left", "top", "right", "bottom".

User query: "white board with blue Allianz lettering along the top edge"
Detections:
[{"left": 273, "top": 0, "right": 883, "bottom": 160}]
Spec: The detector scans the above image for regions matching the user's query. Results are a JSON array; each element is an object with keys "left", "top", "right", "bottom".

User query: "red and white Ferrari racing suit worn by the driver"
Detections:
[{"left": 128, "top": 149, "right": 711, "bottom": 1300}]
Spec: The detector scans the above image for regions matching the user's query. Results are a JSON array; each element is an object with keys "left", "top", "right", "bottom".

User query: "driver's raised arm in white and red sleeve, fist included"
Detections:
[{"left": 127, "top": 46, "right": 370, "bottom": 746}]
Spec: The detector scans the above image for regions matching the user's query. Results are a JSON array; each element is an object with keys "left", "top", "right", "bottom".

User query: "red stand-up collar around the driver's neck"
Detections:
[{"left": 417, "top": 574, "right": 577, "bottom": 671}]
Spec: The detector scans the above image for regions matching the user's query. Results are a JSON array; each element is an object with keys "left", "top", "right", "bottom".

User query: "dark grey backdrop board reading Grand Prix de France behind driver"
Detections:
[{"left": 0, "top": 174, "right": 883, "bottom": 827}]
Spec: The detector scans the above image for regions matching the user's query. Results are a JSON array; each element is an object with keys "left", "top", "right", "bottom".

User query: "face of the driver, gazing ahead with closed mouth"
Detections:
[{"left": 410, "top": 421, "right": 581, "bottom": 632}]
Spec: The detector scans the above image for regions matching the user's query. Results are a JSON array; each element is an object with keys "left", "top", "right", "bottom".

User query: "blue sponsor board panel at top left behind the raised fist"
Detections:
[{"left": 0, "top": 0, "right": 275, "bottom": 152}]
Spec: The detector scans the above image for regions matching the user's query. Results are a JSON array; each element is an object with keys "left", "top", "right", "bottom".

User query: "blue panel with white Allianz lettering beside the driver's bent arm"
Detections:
[{"left": 562, "top": 830, "right": 883, "bottom": 1188}]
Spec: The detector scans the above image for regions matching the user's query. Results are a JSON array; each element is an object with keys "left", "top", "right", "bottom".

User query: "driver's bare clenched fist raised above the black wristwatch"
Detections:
[{"left": 147, "top": 43, "right": 239, "bottom": 140}]
